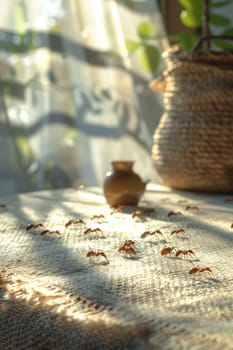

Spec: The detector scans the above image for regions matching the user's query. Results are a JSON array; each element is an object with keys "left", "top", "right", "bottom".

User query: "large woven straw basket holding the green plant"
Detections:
[{"left": 150, "top": 45, "right": 233, "bottom": 192}]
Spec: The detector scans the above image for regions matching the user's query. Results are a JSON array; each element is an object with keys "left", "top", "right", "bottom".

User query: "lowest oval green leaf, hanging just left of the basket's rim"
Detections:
[{"left": 140, "top": 45, "right": 160, "bottom": 74}]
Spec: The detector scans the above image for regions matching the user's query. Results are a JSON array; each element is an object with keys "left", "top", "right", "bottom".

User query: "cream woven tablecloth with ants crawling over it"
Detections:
[{"left": 0, "top": 185, "right": 233, "bottom": 350}]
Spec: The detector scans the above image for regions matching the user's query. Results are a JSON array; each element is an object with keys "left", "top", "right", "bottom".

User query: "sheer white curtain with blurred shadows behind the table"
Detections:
[{"left": 0, "top": 0, "right": 166, "bottom": 194}]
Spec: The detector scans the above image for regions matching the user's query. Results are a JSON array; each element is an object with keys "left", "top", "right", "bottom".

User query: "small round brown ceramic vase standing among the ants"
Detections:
[{"left": 103, "top": 161, "right": 147, "bottom": 207}]
